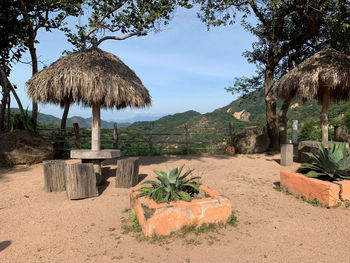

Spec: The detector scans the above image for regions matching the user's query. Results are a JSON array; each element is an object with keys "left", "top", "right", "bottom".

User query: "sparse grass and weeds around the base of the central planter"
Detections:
[{"left": 121, "top": 209, "right": 238, "bottom": 246}]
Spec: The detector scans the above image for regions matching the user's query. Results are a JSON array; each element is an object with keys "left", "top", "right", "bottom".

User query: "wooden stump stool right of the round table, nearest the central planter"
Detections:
[{"left": 115, "top": 157, "right": 139, "bottom": 188}]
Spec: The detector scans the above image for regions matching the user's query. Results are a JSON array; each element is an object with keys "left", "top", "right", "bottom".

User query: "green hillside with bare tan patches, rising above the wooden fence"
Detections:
[{"left": 129, "top": 90, "right": 350, "bottom": 132}]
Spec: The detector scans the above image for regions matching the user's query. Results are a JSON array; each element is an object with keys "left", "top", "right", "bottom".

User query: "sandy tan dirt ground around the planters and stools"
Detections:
[{"left": 0, "top": 154, "right": 350, "bottom": 263}]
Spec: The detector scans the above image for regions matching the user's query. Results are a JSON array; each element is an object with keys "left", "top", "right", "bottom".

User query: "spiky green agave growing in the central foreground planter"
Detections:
[{"left": 137, "top": 165, "right": 200, "bottom": 203}]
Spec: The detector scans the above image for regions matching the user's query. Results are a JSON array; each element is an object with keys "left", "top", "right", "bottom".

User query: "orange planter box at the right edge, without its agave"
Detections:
[{"left": 280, "top": 170, "right": 350, "bottom": 207}]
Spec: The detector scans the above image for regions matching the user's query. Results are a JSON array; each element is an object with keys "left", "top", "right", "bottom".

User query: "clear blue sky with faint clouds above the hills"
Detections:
[{"left": 10, "top": 6, "right": 255, "bottom": 121}]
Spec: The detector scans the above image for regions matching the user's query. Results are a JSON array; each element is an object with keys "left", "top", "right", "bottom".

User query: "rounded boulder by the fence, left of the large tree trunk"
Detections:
[{"left": 233, "top": 131, "right": 270, "bottom": 153}]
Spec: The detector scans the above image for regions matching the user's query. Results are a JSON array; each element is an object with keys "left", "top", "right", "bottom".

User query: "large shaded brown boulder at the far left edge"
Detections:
[{"left": 0, "top": 130, "right": 55, "bottom": 164}]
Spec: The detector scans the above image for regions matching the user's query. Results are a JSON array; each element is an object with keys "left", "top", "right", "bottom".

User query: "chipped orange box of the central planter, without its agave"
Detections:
[{"left": 130, "top": 185, "right": 232, "bottom": 237}]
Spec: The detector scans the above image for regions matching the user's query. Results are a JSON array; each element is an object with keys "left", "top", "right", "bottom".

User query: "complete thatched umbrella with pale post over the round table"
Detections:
[{"left": 26, "top": 48, "right": 151, "bottom": 151}]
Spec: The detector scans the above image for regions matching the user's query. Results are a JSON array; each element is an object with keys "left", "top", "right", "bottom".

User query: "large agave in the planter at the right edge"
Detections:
[{"left": 299, "top": 142, "right": 350, "bottom": 181}]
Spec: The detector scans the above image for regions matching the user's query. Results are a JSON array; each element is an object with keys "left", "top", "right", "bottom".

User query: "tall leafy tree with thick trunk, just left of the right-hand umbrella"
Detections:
[{"left": 196, "top": 0, "right": 349, "bottom": 148}]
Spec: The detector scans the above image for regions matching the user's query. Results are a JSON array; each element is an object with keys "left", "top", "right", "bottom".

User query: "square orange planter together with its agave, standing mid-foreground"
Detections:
[{"left": 130, "top": 166, "right": 232, "bottom": 237}]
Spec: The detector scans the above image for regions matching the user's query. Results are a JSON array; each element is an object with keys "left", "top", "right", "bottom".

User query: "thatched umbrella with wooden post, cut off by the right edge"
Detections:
[{"left": 275, "top": 47, "right": 350, "bottom": 146}]
